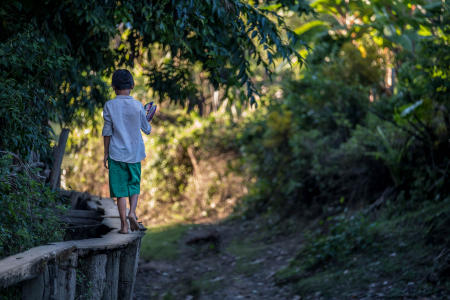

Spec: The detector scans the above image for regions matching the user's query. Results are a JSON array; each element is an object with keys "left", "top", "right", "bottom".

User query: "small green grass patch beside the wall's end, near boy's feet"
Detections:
[{"left": 140, "top": 224, "right": 194, "bottom": 260}]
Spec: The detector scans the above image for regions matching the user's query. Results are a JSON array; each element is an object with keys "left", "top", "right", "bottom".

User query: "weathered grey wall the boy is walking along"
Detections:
[{"left": 0, "top": 197, "right": 144, "bottom": 300}]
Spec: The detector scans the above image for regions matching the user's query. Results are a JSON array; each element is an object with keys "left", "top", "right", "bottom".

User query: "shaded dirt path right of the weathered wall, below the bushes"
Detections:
[{"left": 134, "top": 220, "right": 302, "bottom": 300}]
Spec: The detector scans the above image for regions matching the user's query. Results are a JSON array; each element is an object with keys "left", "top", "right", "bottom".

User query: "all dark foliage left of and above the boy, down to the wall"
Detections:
[{"left": 0, "top": 0, "right": 308, "bottom": 254}]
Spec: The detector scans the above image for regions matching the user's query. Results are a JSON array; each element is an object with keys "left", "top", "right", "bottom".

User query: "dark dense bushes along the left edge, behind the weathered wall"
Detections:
[{"left": 0, "top": 26, "right": 70, "bottom": 257}]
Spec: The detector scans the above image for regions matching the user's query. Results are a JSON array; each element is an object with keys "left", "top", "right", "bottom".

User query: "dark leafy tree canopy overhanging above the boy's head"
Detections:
[{"left": 0, "top": 0, "right": 308, "bottom": 112}]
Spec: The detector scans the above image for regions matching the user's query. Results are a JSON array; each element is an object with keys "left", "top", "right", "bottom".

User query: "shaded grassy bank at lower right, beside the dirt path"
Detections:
[{"left": 276, "top": 201, "right": 450, "bottom": 298}]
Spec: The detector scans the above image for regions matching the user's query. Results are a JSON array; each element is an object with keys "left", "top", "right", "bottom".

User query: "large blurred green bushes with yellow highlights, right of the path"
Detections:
[{"left": 239, "top": 1, "right": 450, "bottom": 216}]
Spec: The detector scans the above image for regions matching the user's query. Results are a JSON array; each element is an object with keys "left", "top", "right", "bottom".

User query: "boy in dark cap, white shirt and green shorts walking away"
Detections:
[{"left": 102, "top": 69, "right": 152, "bottom": 234}]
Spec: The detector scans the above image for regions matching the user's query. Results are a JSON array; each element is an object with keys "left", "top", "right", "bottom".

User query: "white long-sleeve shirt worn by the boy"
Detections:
[{"left": 102, "top": 95, "right": 152, "bottom": 163}]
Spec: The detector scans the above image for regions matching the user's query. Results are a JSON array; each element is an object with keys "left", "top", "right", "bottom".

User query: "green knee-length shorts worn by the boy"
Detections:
[{"left": 108, "top": 157, "right": 141, "bottom": 197}]
